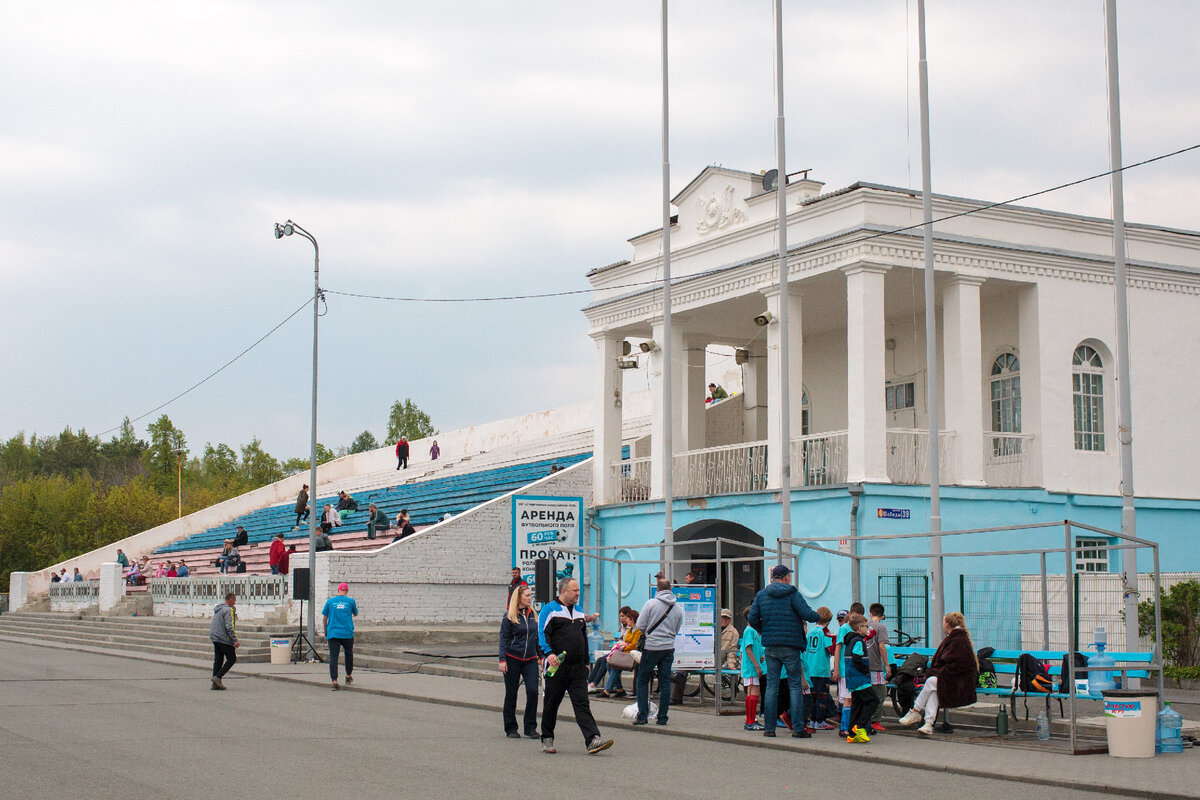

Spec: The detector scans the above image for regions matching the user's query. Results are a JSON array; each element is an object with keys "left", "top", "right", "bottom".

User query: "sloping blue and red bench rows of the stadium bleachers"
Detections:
[{"left": 151, "top": 453, "right": 590, "bottom": 561}]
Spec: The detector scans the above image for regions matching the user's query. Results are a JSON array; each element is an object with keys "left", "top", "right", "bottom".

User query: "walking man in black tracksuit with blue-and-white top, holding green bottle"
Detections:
[{"left": 538, "top": 578, "right": 612, "bottom": 756}]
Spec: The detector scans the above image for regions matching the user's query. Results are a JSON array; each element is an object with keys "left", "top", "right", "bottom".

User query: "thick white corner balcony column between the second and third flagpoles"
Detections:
[{"left": 842, "top": 264, "right": 888, "bottom": 483}]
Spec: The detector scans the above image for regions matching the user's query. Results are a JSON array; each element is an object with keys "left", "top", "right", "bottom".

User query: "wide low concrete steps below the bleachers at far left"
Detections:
[{"left": 0, "top": 610, "right": 295, "bottom": 662}]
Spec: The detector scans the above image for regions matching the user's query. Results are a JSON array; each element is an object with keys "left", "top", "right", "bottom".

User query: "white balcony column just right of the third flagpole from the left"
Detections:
[{"left": 942, "top": 275, "right": 984, "bottom": 486}]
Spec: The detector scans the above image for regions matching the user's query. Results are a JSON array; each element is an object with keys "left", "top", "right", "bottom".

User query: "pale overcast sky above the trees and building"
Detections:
[{"left": 0, "top": 0, "right": 1200, "bottom": 458}]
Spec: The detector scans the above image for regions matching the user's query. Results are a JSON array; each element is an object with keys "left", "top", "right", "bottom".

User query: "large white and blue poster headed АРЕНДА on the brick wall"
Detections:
[{"left": 512, "top": 494, "right": 583, "bottom": 604}]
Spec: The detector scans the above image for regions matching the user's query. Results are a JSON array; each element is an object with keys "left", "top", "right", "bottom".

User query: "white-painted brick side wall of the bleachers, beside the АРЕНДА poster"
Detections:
[{"left": 316, "top": 459, "right": 592, "bottom": 624}]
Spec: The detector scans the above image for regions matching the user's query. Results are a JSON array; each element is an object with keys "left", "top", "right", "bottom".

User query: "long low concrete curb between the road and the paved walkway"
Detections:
[{"left": 0, "top": 633, "right": 1195, "bottom": 800}]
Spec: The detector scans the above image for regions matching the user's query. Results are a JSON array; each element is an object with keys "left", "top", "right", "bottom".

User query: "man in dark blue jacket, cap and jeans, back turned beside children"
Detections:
[{"left": 746, "top": 564, "right": 821, "bottom": 739}]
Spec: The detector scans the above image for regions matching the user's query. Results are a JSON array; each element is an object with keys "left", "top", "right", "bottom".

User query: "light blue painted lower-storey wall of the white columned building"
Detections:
[{"left": 593, "top": 485, "right": 1200, "bottom": 630}]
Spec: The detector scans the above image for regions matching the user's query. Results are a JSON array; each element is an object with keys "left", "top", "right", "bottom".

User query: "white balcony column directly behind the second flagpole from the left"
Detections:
[{"left": 760, "top": 285, "right": 801, "bottom": 489}]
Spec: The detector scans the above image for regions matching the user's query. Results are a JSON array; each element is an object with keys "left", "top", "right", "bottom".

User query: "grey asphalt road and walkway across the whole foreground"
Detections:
[{"left": 0, "top": 640, "right": 1200, "bottom": 800}]
